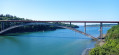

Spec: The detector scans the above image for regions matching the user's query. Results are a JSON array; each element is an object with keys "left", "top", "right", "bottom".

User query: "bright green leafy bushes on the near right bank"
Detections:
[{"left": 89, "top": 25, "right": 119, "bottom": 55}]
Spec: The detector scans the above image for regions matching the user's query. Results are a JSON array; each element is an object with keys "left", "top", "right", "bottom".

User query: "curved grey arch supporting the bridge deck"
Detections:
[{"left": 0, "top": 23, "right": 97, "bottom": 40}]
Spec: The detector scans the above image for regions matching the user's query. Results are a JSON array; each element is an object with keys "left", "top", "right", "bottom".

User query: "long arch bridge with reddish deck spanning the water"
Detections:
[{"left": 0, "top": 20, "right": 119, "bottom": 40}]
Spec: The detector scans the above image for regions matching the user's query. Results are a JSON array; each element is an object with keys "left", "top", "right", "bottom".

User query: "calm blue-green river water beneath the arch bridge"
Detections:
[{"left": 0, "top": 26, "right": 111, "bottom": 55}]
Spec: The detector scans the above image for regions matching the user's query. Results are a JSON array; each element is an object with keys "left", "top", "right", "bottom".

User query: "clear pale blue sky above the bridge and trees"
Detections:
[{"left": 0, "top": 0, "right": 119, "bottom": 21}]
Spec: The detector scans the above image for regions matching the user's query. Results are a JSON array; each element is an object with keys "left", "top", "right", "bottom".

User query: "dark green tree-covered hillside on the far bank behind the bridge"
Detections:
[{"left": 0, "top": 14, "right": 78, "bottom": 34}]
